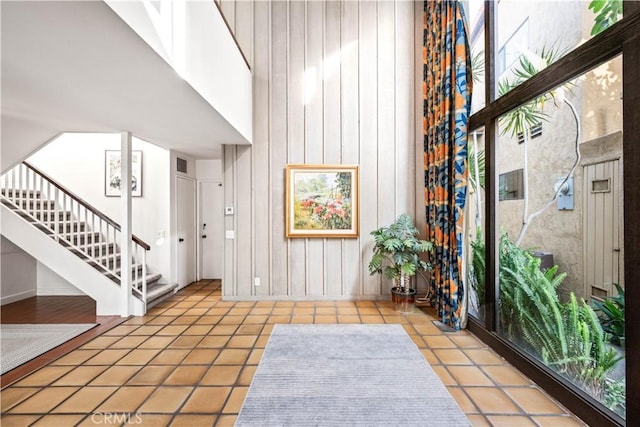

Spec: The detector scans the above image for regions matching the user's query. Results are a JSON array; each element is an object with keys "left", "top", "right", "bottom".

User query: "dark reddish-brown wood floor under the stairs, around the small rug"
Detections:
[{"left": 0, "top": 296, "right": 127, "bottom": 388}]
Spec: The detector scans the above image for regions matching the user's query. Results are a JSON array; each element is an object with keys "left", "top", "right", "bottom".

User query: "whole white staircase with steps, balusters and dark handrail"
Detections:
[{"left": 0, "top": 162, "right": 177, "bottom": 314}]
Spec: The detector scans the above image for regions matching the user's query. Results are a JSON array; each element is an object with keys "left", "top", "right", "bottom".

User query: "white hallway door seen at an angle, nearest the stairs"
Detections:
[{"left": 177, "top": 177, "right": 196, "bottom": 288}]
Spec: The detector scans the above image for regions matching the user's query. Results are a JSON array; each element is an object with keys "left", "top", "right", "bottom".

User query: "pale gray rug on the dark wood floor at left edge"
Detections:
[{"left": 0, "top": 323, "right": 96, "bottom": 374}]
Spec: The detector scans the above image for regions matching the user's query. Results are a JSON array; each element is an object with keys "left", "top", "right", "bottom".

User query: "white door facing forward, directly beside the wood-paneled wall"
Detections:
[{"left": 198, "top": 181, "right": 224, "bottom": 279}]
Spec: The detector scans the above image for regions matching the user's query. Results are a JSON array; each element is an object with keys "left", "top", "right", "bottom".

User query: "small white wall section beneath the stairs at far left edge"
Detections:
[{"left": 0, "top": 237, "right": 37, "bottom": 305}]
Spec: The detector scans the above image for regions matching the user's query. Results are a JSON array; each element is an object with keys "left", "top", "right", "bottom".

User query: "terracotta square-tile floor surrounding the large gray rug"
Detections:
[{"left": 0, "top": 281, "right": 584, "bottom": 427}]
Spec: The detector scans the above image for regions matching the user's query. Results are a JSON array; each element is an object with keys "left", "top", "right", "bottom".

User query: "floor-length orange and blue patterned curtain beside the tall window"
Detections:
[{"left": 423, "top": 0, "right": 472, "bottom": 329}]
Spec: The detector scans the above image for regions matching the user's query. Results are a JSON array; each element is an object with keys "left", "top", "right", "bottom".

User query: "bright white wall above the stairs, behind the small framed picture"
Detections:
[{"left": 27, "top": 133, "right": 171, "bottom": 282}]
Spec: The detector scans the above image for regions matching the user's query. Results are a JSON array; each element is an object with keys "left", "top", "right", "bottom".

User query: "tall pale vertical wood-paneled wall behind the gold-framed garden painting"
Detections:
[{"left": 221, "top": 0, "right": 424, "bottom": 300}]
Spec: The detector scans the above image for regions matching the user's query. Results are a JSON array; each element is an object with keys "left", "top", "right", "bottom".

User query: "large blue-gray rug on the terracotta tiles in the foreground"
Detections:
[{"left": 236, "top": 325, "right": 470, "bottom": 427}]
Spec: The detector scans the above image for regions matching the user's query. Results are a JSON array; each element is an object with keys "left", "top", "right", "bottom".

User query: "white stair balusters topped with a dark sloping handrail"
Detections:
[{"left": 0, "top": 162, "right": 151, "bottom": 304}]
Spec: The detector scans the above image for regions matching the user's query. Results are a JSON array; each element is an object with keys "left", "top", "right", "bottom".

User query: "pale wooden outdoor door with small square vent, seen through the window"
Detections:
[{"left": 583, "top": 160, "right": 622, "bottom": 299}]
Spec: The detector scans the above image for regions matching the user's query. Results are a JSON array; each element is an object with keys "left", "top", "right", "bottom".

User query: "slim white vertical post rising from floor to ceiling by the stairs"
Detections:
[{"left": 120, "top": 132, "right": 132, "bottom": 317}]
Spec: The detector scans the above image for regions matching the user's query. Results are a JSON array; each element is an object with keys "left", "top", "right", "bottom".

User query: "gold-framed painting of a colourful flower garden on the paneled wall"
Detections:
[{"left": 285, "top": 165, "right": 360, "bottom": 238}]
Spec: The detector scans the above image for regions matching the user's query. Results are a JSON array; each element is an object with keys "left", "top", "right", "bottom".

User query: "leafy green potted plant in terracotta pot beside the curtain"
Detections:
[{"left": 369, "top": 214, "right": 433, "bottom": 311}]
